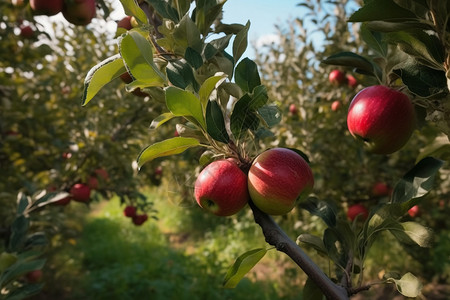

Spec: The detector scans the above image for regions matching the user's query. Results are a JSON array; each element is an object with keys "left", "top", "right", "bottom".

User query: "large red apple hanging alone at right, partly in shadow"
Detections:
[{"left": 347, "top": 85, "right": 415, "bottom": 154}]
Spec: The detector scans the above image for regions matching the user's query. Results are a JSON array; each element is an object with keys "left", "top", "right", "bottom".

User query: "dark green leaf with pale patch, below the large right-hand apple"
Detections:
[{"left": 392, "top": 157, "right": 444, "bottom": 203}]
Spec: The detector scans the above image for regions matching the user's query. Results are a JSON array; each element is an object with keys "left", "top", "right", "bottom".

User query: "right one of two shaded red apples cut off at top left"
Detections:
[{"left": 62, "top": 0, "right": 96, "bottom": 25}]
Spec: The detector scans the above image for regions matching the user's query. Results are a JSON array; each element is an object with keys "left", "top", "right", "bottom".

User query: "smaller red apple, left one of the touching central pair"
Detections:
[{"left": 194, "top": 159, "right": 249, "bottom": 217}]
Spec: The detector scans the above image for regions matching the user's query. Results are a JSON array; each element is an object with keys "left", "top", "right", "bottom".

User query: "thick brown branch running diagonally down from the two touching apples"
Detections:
[{"left": 250, "top": 201, "right": 349, "bottom": 300}]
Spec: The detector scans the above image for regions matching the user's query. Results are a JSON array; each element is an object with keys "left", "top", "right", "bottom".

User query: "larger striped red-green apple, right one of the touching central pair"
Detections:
[{"left": 248, "top": 148, "right": 314, "bottom": 215}]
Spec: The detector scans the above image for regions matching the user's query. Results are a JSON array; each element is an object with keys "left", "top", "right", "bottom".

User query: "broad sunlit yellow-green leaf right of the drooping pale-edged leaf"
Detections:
[{"left": 119, "top": 31, "right": 166, "bottom": 88}]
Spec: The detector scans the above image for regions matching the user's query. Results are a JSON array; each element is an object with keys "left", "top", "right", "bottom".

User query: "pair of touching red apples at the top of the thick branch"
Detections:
[{"left": 194, "top": 148, "right": 314, "bottom": 216}]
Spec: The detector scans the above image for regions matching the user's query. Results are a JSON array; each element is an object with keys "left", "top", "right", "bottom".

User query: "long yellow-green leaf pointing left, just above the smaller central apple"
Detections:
[{"left": 137, "top": 137, "right": 200, "bottom": 168}]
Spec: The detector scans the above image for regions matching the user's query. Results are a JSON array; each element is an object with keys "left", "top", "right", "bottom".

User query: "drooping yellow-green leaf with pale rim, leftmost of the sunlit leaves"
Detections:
[{"left": 81, "top": 54, "right": 127, "bottom": 105}]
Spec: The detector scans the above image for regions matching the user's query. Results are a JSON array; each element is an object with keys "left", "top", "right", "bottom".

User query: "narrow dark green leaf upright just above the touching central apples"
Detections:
[{"left": 206, "top": 101, "right": 230, "bottom": 143}]
